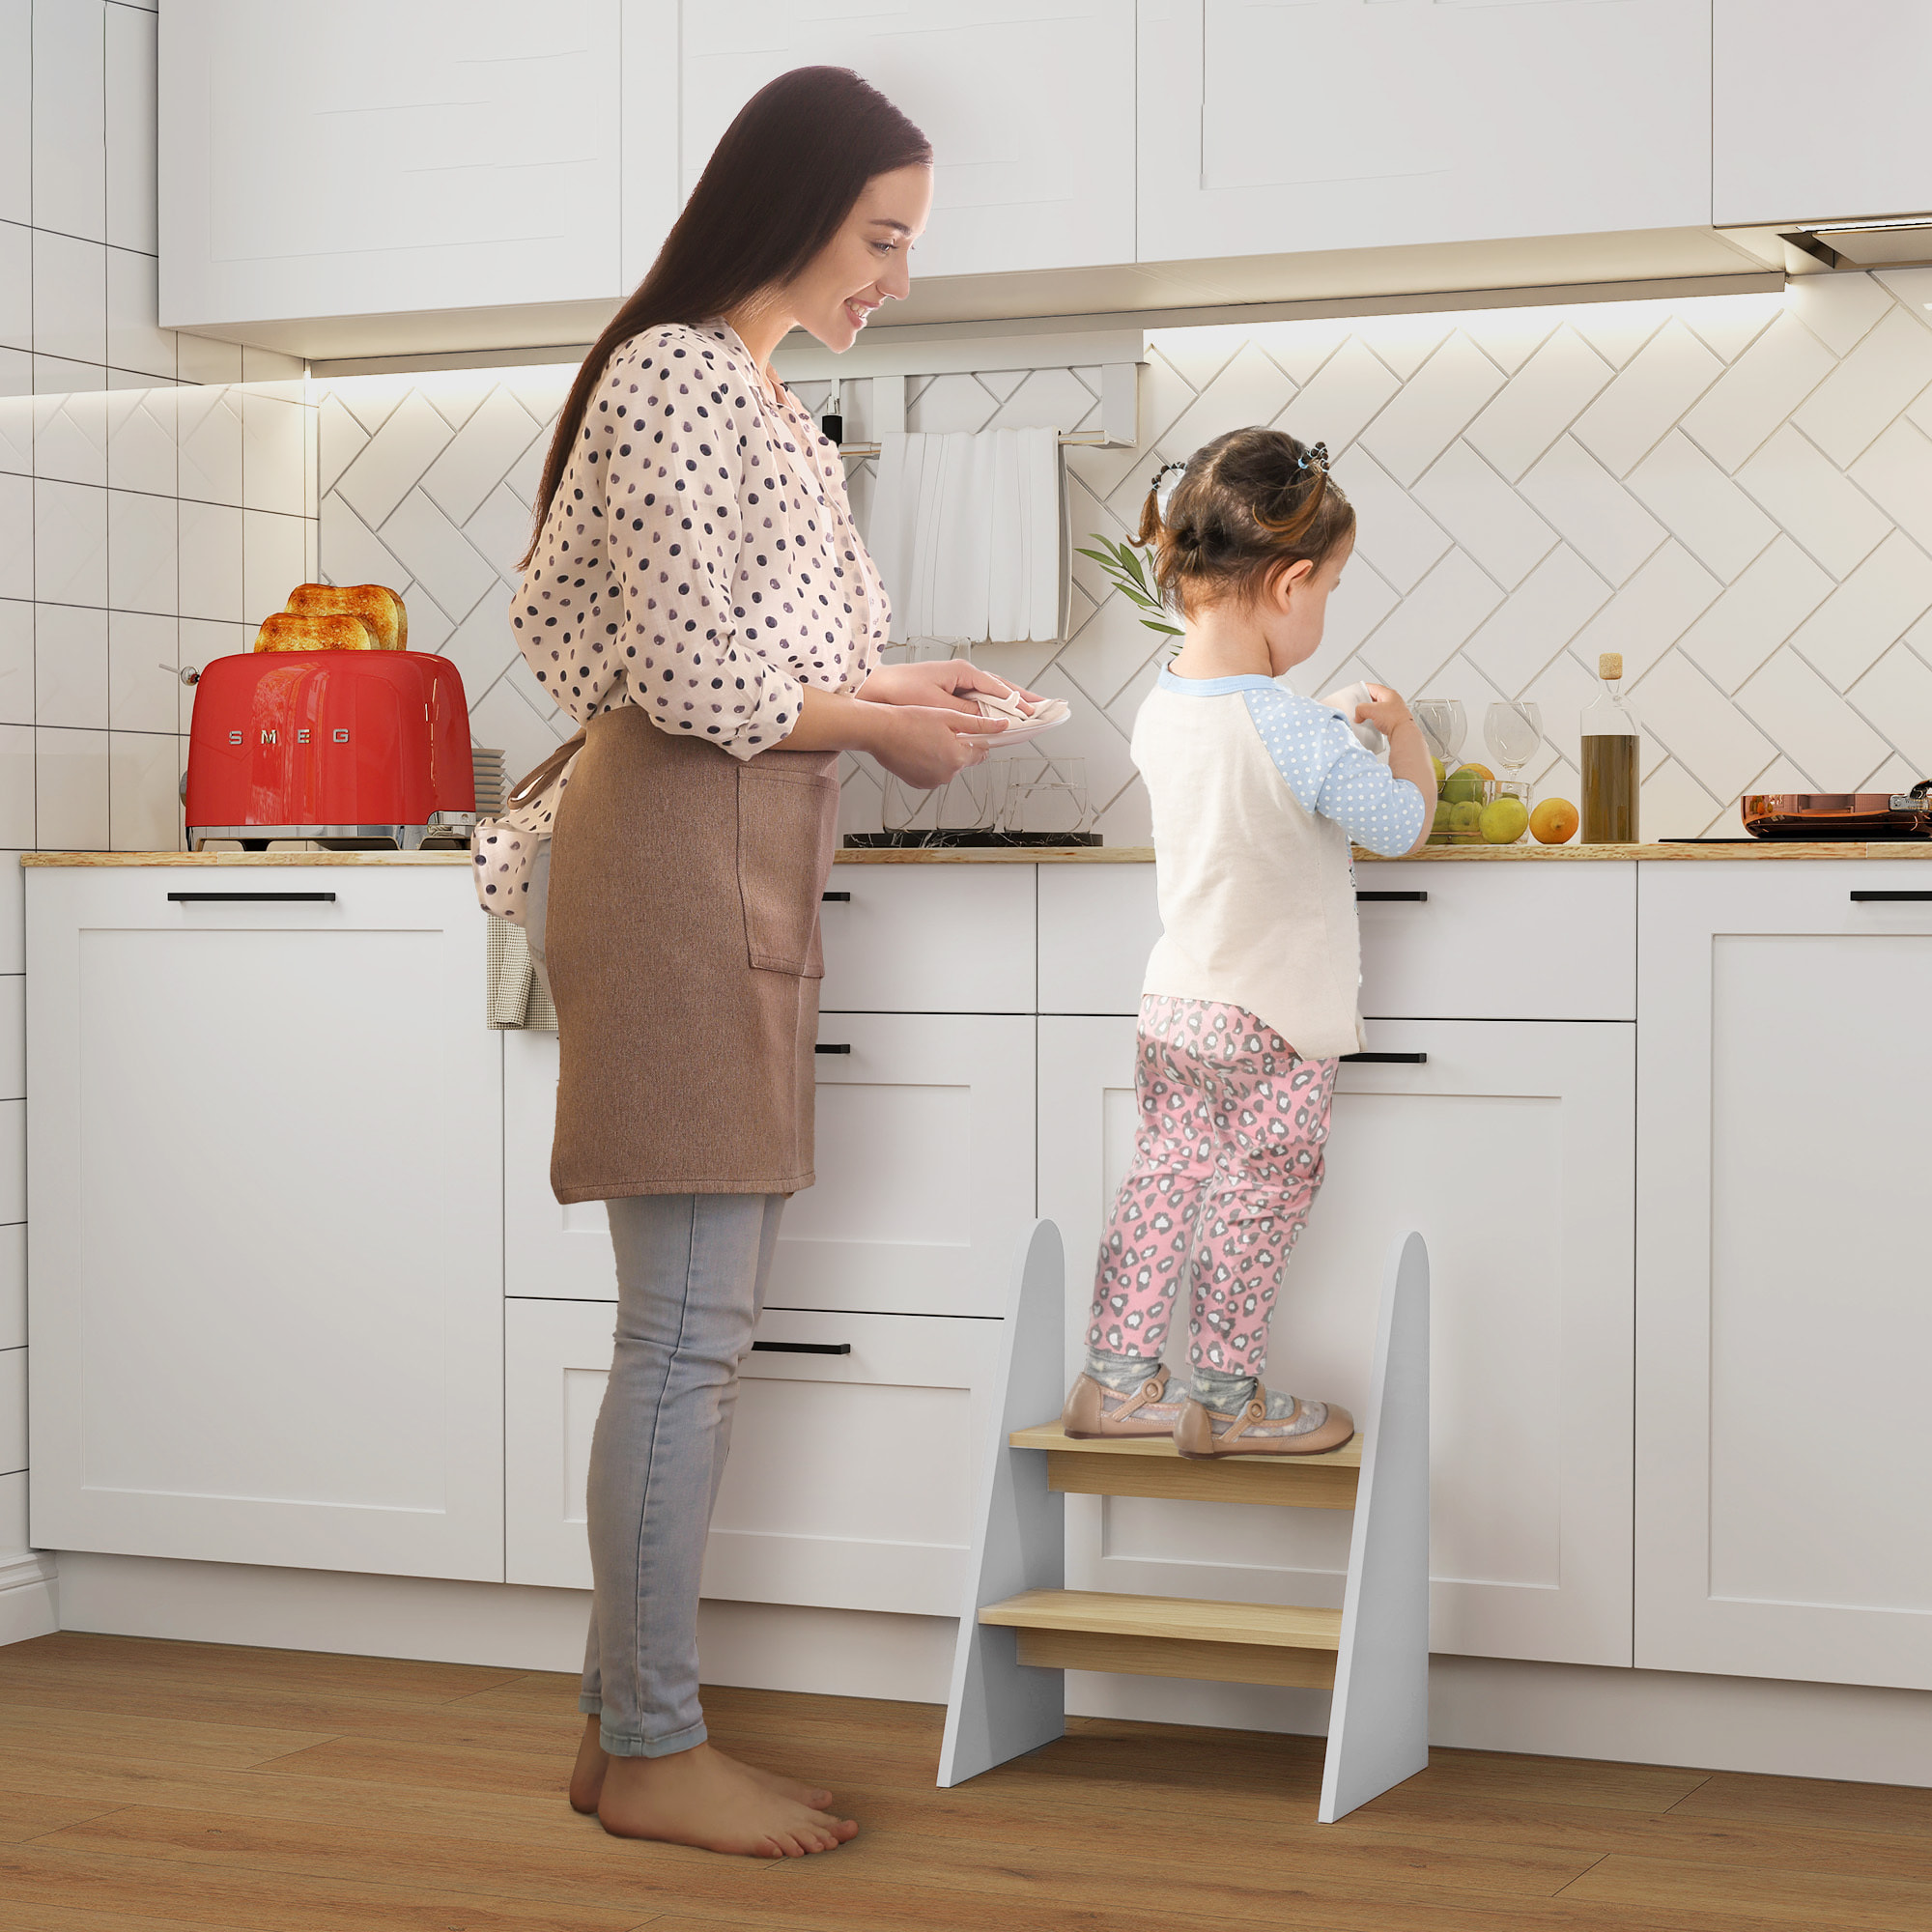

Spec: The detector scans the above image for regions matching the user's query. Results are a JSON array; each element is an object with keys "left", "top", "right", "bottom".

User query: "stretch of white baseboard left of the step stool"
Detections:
[{"left": 58, "top": 1551, "right": 956, "bottom": 1704}]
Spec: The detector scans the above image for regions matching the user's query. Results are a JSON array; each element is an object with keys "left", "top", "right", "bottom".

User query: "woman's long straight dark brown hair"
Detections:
[{"left": 520, "top": 68, "right": 933, "bottom": 570}]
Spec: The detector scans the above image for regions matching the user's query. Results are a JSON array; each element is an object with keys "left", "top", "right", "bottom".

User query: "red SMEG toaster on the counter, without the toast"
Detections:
[{"left": 182, "top": 651, "right": 475, "bottom": 852}]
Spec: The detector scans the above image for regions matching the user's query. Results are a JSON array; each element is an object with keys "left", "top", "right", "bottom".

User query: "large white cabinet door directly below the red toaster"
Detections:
[{"left": 27, "top": 866, "right": 502, "bottom": 1580}]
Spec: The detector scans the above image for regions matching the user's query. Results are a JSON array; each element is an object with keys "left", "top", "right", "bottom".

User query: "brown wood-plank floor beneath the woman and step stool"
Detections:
[{"left": 0, "top": 1634, "right": 1932, "bottom": 1932}]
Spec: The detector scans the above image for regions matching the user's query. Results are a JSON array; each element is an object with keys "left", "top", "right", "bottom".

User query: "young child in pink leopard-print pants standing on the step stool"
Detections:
[{"left": 1063, "top": 429, "right": 1435, "bottom": 1457}]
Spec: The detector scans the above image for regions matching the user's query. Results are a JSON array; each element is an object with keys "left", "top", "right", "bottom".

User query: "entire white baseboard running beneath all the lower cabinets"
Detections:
[{"left": 48, "top": 1551, "right": 1932, "bottom": 1785}]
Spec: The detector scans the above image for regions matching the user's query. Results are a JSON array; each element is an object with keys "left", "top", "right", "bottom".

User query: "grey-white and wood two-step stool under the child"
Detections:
[{"left": 939, "top": 1221, "right": 1430, "bottom": 1824}]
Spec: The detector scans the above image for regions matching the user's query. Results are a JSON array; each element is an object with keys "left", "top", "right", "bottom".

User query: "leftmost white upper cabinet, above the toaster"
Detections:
[{"left": 160, "top": 0, "right": 638, "bottom": 355}]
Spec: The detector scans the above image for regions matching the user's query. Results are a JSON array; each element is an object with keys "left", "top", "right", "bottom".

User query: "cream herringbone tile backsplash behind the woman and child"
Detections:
[{"left": 321, "top": 270, "right": 1932, "bottom": 844}]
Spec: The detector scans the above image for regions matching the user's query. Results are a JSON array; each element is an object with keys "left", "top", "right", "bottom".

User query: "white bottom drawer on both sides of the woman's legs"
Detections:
[{"left": 504, "top": 1300, "right": 1001, "bottom": 1617}]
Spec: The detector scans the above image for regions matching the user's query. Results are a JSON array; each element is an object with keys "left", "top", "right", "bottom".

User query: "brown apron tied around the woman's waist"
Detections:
[{"left": 545, "top": 705, "right": 838, "bottom": 1202}]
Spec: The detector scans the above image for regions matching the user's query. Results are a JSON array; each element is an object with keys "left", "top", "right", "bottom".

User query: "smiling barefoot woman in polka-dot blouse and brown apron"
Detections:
[{"left": 506, "top": 68, "right": 1009, "bottom": 1857}]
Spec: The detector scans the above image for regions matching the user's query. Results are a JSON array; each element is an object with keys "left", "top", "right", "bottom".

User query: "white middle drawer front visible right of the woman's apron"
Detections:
[{"left": 765, "top": 1012, "right": 1034, "bottom": 1316}]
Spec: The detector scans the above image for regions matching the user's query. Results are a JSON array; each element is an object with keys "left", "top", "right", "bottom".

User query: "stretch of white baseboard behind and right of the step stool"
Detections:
[{"left": 1066, "top": 1656, "right": 1932, "bottom": 1785}]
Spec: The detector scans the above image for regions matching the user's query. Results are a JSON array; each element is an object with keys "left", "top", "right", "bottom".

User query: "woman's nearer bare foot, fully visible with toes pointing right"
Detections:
[{"left": 597, "top": 1745, "right": 858, "bottom": 1859}]
